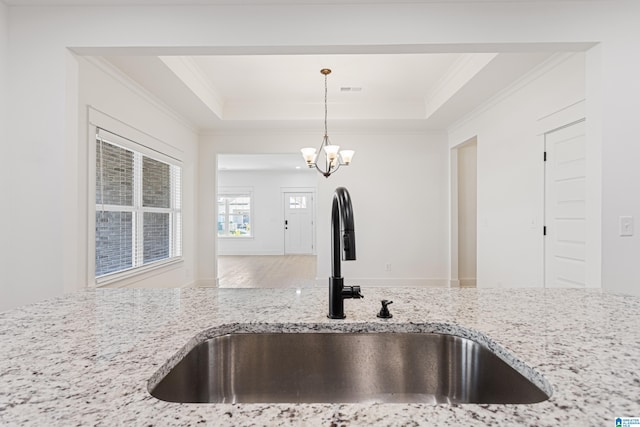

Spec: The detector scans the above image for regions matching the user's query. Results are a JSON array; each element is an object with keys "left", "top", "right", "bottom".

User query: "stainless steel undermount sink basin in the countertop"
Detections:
[{"left": 150, "top": 333, "right": 549, "bottom": 403}]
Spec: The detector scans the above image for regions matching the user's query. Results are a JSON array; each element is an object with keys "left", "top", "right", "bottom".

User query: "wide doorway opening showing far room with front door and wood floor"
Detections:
[{"left": 216, "top": 154, "right": 317, "bottom": 288}]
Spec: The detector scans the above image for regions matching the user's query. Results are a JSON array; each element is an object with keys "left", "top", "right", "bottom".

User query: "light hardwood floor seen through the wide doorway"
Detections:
[{"left": 218, "top": 255, "right": 317, "bottom": 288}]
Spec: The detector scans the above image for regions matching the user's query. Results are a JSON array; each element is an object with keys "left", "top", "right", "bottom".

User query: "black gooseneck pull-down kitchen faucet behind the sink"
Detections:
[{"left": 327, "top": 187, "right": 362, "bottom": 319}]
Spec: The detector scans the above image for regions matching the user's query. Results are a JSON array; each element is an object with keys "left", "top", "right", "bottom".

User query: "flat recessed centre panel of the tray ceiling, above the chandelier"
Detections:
[{"left": 193, "top": 54, "right": 460, "bottom": 104}]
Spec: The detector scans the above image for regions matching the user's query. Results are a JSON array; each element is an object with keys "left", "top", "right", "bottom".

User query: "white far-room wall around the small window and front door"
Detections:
[{"left": 214, "top": 170, "right": 318, "bottom": 255}]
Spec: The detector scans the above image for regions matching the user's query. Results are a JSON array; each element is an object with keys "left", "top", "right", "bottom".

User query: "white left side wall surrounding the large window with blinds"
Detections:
[{"left": 74, "top": 57, "right": 198, "bottom": 290}]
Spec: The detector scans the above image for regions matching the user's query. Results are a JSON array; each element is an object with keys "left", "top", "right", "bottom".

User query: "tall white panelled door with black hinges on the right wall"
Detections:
[{"left": 544, "top": 120, "right": 586, "bottom": 288}]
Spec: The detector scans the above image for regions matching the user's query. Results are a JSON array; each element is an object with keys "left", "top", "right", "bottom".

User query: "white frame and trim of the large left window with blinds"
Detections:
[{"left": 87, "top": 108, "right": 184, "bottom": 287}]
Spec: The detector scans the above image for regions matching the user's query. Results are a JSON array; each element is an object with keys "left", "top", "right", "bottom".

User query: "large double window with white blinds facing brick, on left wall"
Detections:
[{"left": 95, "top": 129, "right": 182, "bottom": 278}]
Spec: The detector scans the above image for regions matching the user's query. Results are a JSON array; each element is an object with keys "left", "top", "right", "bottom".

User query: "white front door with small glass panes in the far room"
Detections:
[{"left": 284, "top": 193, "right": 313, "bottom": 254}]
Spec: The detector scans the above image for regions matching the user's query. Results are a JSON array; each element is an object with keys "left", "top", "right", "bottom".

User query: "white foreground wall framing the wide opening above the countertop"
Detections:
[{"left": 2, "top": 0, "right": 640, "bottom": 306}]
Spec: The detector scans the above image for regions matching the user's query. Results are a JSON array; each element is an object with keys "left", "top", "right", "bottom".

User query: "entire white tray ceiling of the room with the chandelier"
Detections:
[{"left": 99, "top": 51, "right": 553, "bottom": 133}]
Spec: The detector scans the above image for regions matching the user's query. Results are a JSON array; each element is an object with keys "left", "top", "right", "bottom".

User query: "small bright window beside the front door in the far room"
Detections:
[{"left": 218, "top": 192, "right": 252, "bottom": 237}]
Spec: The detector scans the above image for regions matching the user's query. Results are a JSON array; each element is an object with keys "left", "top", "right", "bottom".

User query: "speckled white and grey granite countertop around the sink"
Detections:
[{"left": 0, "top": 288, "right": 640, "bottom": 426}]
